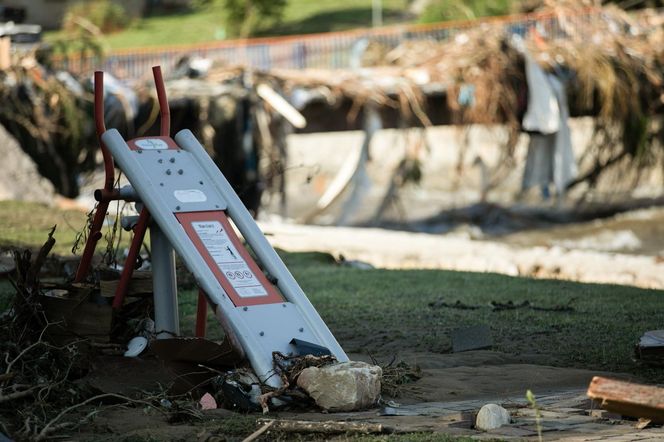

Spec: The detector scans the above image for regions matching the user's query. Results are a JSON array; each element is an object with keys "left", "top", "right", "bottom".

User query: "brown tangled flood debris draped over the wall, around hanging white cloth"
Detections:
[{"left": 200, "top": 1, "right": 664, "bottom": 193}]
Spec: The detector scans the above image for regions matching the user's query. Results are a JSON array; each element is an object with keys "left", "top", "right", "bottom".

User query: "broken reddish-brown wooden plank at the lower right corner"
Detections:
[{"left": 587, "top": 376, "right": 664, "bottom": 423}]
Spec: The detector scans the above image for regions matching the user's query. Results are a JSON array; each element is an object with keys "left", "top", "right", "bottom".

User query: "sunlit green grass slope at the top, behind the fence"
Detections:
[{"left": 45, "top": 0, "right": 406, "bottom": 50}]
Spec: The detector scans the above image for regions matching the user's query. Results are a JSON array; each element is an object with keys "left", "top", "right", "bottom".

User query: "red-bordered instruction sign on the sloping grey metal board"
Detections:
[{"left": 174, "top": 211, "right": 284, "bottom": 307}]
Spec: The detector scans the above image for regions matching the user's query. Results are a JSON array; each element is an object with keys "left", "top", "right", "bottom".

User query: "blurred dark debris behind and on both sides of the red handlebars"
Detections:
[{"left": 0, "top": 57, "right": 270, "bottom": 211}]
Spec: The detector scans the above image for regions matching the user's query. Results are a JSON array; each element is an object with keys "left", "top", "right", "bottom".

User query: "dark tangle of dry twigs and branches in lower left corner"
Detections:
[{"left": 0, "top": 231, "right": 201, "bottom": 441}]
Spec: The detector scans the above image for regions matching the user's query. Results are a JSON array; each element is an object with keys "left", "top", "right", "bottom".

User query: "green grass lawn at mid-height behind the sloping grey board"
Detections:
[{"left": 0, "top": 202, "right": 664, "bottom": 382}]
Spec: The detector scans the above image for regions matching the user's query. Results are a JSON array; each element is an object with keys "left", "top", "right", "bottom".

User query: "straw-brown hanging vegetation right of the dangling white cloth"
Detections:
[{"left": 531, "top": 6, "right": 664, "bottom": 185}]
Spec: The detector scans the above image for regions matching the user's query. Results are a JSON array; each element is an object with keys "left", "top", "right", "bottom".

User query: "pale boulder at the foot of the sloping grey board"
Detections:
[{"left": 297, "top": 362, "right": 383, "bottom": 411}]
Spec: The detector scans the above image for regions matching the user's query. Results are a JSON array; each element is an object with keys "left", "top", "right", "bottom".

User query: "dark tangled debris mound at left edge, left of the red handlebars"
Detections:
[{"left": 0, "top": 62, "right": 97, "bottom": 197}]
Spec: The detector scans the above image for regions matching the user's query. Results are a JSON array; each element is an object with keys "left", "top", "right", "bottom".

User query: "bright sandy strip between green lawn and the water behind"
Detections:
[{"left": 261, "top": 223, "right": 664, "bottom": 289}]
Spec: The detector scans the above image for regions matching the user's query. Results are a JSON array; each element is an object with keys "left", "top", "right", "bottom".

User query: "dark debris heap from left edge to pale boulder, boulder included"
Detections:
[{"left": 0, "top": 228, "right": 381, "bottom": 440}]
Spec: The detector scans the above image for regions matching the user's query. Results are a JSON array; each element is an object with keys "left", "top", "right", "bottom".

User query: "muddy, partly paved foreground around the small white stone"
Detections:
[{"left": 63, "top": 340, "right": 664, "bottom": 441}]
